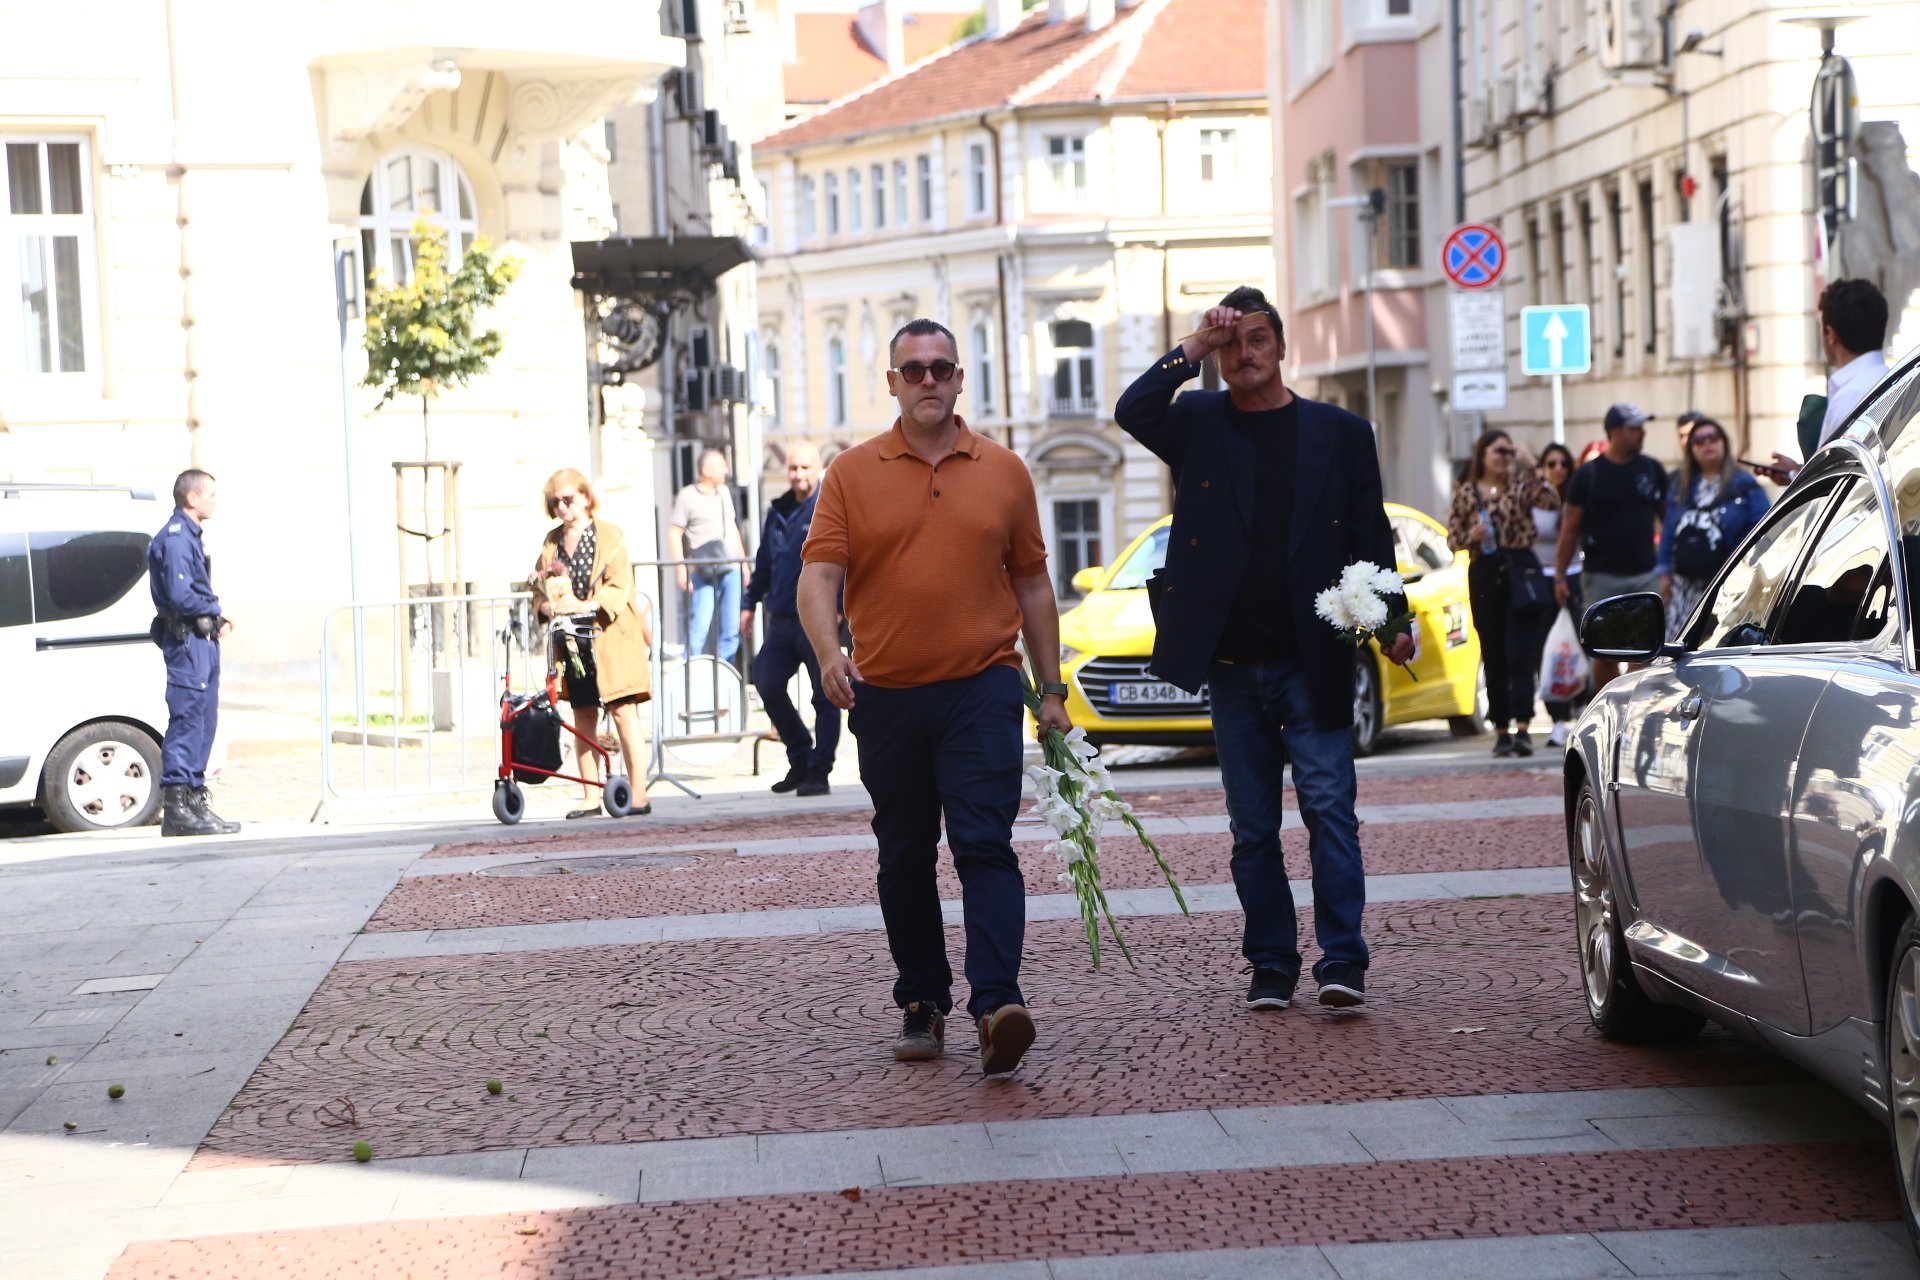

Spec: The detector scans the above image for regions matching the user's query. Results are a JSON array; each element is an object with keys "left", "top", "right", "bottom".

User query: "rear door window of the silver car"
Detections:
[{"left": 1772, "top": 484, "right": 1893, "bottom": 645}]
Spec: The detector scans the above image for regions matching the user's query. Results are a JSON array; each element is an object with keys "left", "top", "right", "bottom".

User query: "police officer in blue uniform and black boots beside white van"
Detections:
[{"left": 146, "top": 470, "right": 240, "bottom": 835}]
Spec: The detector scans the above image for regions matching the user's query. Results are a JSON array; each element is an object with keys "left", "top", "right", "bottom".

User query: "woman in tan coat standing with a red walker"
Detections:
[{"left": 532, "top": 466, "right": 653, "bottom": 818}]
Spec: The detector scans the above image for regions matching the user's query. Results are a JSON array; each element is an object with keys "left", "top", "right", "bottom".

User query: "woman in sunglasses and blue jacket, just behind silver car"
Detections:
[{"left": 1653, "top": 418, "right": 1768, "bottom": 639}]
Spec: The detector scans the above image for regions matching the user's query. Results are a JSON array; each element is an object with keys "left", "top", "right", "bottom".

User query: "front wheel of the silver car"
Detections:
[{"left": 1567, "top": 779, "right": 1707, "bottom": 1042}]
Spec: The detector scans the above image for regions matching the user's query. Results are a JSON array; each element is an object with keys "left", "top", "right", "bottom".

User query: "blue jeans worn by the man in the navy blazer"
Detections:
[{"left": 1208, "top": 658, "right": 1367, "bottom": 981}]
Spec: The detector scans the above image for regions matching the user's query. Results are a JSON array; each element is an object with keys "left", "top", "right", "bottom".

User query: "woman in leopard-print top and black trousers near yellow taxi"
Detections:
[{"left": 1446, "top": 428, "right": 1559, "bottom": 756}]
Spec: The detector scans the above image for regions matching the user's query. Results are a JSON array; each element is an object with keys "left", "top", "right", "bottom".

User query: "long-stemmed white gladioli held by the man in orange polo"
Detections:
[{"left": 1020, "top": 674, "right": 1190, "bottom": 969}]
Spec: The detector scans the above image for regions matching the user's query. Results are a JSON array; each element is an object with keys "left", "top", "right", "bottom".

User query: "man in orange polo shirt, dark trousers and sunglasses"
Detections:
[{"left": 799, "top": 320, "right": 1071, "bottom": 1075}]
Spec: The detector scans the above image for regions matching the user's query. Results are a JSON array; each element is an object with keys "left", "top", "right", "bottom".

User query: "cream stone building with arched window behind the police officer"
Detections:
[{"left": 0, "top": 0, "right": 778, "bottom": 674}]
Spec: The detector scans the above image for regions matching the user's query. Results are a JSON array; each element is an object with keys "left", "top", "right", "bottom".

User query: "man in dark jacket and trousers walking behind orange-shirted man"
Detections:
[{"left": 739, "top": 441, "right": 839, "bottom": 796}]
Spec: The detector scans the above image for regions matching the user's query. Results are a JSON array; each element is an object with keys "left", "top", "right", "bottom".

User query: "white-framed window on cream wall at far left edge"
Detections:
[{"left": 0, "top": 132, "right": 104, "bottom": 388}]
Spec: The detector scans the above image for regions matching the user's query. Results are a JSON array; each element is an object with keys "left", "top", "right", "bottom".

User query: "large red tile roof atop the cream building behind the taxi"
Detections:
[{"left": 755, "top": 0, "right": 1267, "bottom": 152}]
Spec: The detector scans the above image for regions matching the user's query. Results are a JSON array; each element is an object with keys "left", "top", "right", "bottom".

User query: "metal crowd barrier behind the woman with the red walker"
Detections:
[{"left": 313, "top": 558, "right": 787, "bottom": 821}]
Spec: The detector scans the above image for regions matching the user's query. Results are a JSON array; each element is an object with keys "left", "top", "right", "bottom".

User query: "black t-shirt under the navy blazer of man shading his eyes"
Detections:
[{"left": 1217, "top": 401, "right": 1300, "bottom": 662}]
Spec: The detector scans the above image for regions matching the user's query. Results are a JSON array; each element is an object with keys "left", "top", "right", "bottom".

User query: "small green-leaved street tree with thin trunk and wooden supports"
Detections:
[{"left": 361, "top": 217, "right": 520, "bottom": 690}]
